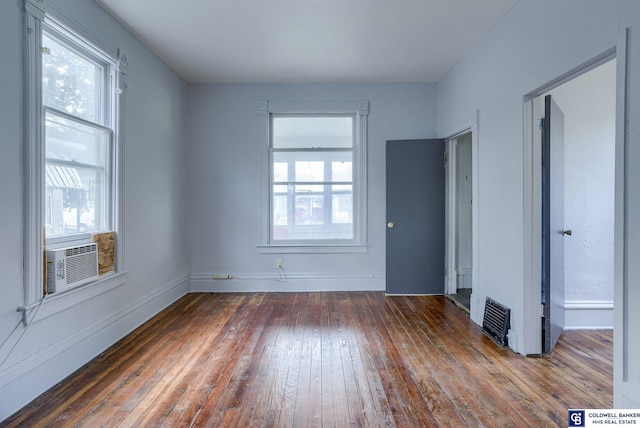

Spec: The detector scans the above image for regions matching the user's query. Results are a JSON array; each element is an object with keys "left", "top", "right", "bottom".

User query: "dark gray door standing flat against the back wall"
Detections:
[{"left": 386, "top": 140, "right": 444, "bottom": 294}]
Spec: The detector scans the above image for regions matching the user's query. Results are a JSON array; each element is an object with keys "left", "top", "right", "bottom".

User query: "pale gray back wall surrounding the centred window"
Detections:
[{"left": 188, "top": 84, "right": 436, "bottom": 291}]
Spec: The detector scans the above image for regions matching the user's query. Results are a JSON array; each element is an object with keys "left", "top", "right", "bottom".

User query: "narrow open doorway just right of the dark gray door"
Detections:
[{"left": 445, "top": 131, "right": 474, "bottom": 313}]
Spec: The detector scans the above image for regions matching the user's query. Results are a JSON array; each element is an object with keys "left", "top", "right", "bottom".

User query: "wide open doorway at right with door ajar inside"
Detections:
[{"left": 533, "top": 56, "right": 616, "bottom": 353}]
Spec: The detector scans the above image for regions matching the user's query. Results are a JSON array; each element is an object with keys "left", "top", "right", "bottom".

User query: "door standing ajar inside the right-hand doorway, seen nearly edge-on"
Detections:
[{"left": 542, "top": 95, "right": 571, "bottom": 353}]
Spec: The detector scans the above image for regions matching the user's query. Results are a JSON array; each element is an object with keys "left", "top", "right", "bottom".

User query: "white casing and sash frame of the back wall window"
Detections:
[{"left": 258, "top": 100, "right": 369, "bottom": 253}]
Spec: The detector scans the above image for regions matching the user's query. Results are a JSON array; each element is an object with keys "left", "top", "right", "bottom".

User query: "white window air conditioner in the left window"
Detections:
[{"left": 47, "top": 244, "right": 98, "bottom": 293}]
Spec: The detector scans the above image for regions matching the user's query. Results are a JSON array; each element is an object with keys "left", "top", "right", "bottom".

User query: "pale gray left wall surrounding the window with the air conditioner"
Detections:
[{"left": 0, "top": 0, "right": 188, "bottom": 420}]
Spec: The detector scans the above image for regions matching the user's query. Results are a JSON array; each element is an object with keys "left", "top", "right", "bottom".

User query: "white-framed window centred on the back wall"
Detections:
[{"left": 263, "top": 101, "right": 368, "bottom": 248}]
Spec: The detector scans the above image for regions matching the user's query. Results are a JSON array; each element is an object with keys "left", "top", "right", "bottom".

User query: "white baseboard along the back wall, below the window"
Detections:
[{"left": 189, "top": 271, "right": 386, "bottom": 293}]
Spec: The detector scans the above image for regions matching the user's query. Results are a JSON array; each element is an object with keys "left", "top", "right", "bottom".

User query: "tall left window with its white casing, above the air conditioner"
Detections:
[{"left": 24, "top": 0, "right": 126, "bottom": 306}]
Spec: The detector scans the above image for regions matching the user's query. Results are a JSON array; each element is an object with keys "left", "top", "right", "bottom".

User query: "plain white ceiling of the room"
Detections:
[{"left": 96, "top": 0, "right": 517, "bottom": 83}]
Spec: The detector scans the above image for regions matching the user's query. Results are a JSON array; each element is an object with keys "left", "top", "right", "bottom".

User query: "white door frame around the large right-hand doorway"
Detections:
[{"left": 521, "top": 45, "right": 626, "bottom": 355}]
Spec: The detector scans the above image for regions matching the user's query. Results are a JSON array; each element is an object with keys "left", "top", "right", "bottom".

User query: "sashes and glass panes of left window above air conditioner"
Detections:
[{"left": 41, "top": 26, "right": 114, "bottom": 238}]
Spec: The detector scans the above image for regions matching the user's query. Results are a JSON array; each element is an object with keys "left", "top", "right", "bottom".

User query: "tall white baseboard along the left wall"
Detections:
[{"left": 0, "top": 275, "right": 189, "bottom": 421}]
